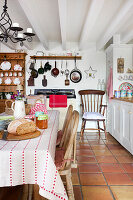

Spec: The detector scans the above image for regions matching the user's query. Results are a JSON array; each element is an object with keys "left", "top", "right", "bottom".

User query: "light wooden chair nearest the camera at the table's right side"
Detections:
[{"left": 55, "top": 111, "right": 79, "bottom": 200}]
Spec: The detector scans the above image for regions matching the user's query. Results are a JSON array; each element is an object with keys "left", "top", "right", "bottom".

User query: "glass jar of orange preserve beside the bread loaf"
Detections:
[{"left": 37, "top": 114, "right": 48, "bottom": 129}]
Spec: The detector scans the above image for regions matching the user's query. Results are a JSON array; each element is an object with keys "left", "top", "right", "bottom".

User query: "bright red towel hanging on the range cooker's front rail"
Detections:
[{"left": 49, "top": 95, "right": 67, "bottom": 108}]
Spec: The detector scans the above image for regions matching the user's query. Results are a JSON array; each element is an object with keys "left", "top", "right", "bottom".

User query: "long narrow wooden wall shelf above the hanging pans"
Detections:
[{"left": 30, "top": 55, "right": 82, "bottom": 60}]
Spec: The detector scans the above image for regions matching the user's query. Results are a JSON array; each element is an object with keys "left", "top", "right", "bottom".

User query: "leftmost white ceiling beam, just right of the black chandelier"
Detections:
[{"left": 18, "top": 0, "right": 48, "bottom": 50}]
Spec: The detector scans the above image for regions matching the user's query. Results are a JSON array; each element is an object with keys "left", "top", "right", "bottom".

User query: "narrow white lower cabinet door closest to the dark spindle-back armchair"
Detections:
[{"left": 112, "top": 102, "right": 121, "bottom": 142}]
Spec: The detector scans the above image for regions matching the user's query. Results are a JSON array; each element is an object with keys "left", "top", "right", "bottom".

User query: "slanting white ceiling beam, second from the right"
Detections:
[{"left": 79, "top": 0, "right": 105, "bottom": 49}]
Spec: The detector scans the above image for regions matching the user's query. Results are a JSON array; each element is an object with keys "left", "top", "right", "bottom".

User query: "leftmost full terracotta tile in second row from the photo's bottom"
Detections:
[{"left": 80, "top": 174, "right": 106, "bottom": 185}]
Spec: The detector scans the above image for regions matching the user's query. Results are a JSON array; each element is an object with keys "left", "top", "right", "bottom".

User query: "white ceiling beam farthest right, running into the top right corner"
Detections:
[{"left": 97, "top": 0, "right": 133, "bottom": 50}]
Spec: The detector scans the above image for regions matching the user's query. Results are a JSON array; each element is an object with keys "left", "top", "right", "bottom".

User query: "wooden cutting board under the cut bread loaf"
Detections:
[{"left": 0, "top": 130, "right": 41, "bottom": 141}]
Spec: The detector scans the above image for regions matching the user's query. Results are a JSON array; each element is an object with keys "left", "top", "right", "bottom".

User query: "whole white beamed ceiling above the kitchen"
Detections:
[{"left": 0, "top": 0, "right": 133, "bottom": 50}]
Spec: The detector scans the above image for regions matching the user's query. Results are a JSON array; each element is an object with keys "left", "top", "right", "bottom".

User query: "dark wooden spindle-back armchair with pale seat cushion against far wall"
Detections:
[{"left": 79, "top": 90, "right": 107, "bottom": 137}]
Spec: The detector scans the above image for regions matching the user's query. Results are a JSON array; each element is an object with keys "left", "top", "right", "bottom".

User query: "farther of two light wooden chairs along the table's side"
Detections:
[{"left": 56, "top": 105, "right": 73, "bottom": 147}]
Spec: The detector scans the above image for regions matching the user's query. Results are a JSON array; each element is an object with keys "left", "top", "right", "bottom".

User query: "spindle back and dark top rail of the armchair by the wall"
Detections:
[{"left": 79, "top": 90, "right": 105, "bottom": 113}]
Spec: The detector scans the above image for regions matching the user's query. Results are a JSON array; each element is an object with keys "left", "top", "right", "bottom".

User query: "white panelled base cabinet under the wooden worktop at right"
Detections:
[{"left": 111, "top": 100, "right": 133, "bottom": 154}]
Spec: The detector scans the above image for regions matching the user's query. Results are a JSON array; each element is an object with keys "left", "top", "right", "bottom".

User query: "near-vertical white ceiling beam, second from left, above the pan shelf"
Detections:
[{"left": 58, "top": 0, "right": 67, "bottom": 50}]
